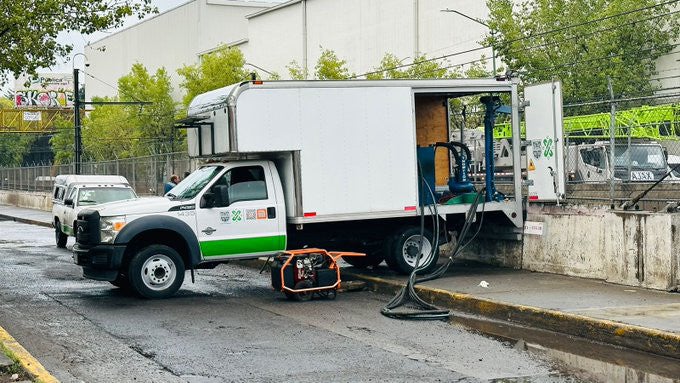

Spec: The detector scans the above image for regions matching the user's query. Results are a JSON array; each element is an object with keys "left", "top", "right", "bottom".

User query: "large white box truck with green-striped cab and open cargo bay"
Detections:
[{"left": 74, "top": 79, "right": 561, "bottom": 298}]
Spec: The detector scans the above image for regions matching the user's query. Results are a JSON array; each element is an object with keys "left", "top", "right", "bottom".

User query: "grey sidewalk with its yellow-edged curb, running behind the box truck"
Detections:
[{"left": 0, "top": 205, "right": 680, "bottom": 359}]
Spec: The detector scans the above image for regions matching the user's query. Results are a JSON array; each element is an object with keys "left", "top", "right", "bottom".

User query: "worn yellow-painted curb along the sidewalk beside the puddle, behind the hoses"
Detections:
[{"left": 342, "top": 271, "right": 680, "bottom": 359}]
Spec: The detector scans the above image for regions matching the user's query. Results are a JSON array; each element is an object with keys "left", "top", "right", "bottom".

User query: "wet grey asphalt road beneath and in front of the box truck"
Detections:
[{"left": 0, "top": 221, "right": 572, "bottom": 382}]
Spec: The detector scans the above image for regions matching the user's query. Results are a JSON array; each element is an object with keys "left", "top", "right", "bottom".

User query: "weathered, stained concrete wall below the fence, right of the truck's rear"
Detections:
[{"left": 522, "top": 205, "right": 680, "bottom": 290}]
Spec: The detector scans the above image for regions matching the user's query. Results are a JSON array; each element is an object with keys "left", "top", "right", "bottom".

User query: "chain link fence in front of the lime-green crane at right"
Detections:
[{"left": 564, "top": 93, "right": 680, "bottom": 210}]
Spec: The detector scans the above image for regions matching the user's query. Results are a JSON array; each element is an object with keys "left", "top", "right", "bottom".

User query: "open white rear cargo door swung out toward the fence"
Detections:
[{"left": 524, "top": 81, "right": 565, "bottom": 201}]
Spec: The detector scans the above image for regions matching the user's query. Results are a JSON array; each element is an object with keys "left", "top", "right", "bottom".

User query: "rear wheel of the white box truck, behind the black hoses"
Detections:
[{"left": 392, "top": 226, "right": 439, "bottom": 274}]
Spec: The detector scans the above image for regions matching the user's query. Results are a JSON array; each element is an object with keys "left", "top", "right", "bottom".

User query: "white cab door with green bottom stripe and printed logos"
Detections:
[{"left": 196, "top": 164, "right": 286, "bottom": 260}]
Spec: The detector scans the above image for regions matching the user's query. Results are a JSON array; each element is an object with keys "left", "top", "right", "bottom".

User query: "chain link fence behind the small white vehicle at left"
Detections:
[{"left": 0, "top": 153, "right": 195, "bottom": 196}]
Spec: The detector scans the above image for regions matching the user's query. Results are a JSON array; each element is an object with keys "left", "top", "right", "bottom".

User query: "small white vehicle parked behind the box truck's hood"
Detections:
[{"left": 52, "top": 174, "right": 137, "bottom": 247}]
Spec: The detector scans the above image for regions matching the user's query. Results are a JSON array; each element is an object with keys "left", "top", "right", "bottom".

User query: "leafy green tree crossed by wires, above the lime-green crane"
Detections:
[{"left": 486, "top": 0, "right": 680, "bottom": 108}]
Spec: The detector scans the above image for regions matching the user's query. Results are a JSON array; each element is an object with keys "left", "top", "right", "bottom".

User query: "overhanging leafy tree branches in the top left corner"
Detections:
[{"left": 0, "top": 0, "right": 157, "bottom": 85}]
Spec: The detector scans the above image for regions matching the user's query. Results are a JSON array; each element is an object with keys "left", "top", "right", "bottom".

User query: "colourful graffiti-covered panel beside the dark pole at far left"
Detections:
[{"left": 14, "top": 73, "right": 73, "bottom": 108}]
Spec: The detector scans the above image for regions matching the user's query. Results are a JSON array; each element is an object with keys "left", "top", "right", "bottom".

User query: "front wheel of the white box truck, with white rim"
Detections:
[{"left": 127, "top": 245, "right": 184, "bottom": 299}]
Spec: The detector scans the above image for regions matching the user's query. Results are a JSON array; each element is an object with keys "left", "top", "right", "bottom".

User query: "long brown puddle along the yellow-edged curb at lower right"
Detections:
[{"left": 451, "top": 316, "right": 680, "bottom": 383}]
